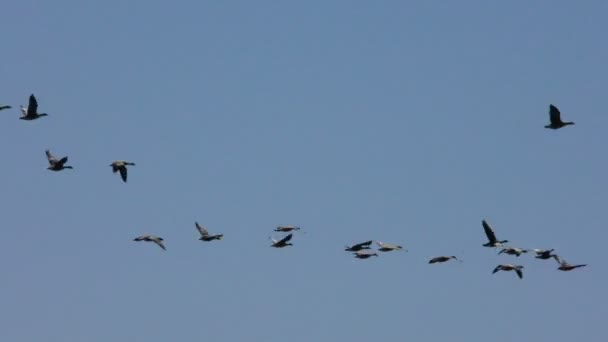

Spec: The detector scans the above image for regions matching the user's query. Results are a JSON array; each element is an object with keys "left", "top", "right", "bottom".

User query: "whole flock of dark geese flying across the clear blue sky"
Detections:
[{"left": 0, "top": 94, "right": 587, "bottom": 279}]
